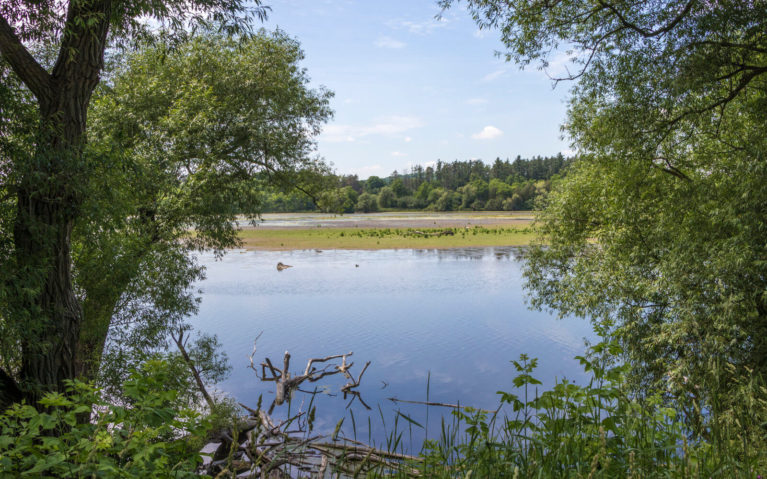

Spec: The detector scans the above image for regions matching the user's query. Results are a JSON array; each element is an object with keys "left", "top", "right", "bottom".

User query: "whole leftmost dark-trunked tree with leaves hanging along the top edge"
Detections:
[{"left": 0, "top": 0, "right": 276, "bottom": 405}]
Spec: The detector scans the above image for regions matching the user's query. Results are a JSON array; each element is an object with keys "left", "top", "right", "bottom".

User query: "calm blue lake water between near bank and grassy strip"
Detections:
[{"left": 193, "top": 248, "right": 593, "bottom": 448}]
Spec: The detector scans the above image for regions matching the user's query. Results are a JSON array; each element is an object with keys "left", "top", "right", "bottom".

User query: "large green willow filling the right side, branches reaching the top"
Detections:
[{"left": 442, "top": 0, "right": 767, "bottom": 431}]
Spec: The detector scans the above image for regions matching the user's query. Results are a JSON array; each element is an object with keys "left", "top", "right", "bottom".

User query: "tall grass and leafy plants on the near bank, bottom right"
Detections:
[{"left": 356, "top": 342, "right": 767, "bottom": 478}]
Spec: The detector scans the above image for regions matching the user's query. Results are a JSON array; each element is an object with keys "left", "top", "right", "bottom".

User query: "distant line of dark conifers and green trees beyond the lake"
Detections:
[{"left": 264, "top": 154, "right": 571, "bottom": 213}]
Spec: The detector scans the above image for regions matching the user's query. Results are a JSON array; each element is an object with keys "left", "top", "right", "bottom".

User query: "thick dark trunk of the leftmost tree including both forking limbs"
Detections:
[{"left": 0, "top": 0, "right": 111, "bottom": 407}]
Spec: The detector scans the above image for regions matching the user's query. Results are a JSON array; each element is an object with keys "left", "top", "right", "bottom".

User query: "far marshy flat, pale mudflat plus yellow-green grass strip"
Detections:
[{"left": 240, "top": 211, "right": 534, "bottom": 250}]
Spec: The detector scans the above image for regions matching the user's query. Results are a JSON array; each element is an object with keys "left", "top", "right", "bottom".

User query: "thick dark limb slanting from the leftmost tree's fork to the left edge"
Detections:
[{"left": 0, "top": 15, "right": 51, "bottom": 100}]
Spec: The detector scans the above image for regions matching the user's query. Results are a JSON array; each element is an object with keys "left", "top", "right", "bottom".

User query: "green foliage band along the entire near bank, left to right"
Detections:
[{"left": 0, "top": 341, "right": 767, "bottom": 478}]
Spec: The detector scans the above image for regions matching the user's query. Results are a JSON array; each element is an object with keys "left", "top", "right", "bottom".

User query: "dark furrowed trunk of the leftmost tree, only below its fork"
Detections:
[{"left": 14, "top": 98, "right": 90, "bottom": 404}]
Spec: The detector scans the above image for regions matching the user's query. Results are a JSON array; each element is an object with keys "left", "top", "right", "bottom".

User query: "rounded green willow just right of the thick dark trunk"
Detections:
[{"left": 73, "top": 31, "right": 332, "bottom": 390}]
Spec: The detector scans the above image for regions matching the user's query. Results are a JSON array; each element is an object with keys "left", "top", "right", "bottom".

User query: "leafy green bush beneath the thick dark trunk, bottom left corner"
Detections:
[{"left": 0, "top": 361, "right": 207, "bottom": 478}]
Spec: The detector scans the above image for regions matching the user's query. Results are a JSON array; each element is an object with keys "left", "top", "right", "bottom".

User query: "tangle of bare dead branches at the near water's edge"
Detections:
[{"left": 206, "top": 334, "right": 421, "bottom": 479}]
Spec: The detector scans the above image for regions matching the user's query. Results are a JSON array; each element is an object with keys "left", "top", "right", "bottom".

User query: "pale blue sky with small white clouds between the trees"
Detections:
[{"left": 265, "top": 0, "right": 570, "bottom": 178}]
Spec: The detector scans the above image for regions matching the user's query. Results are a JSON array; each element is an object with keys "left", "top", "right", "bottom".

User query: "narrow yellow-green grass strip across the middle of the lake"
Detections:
[{"left": 240, "top": 225, "right": 534, "bottom": 250}]
